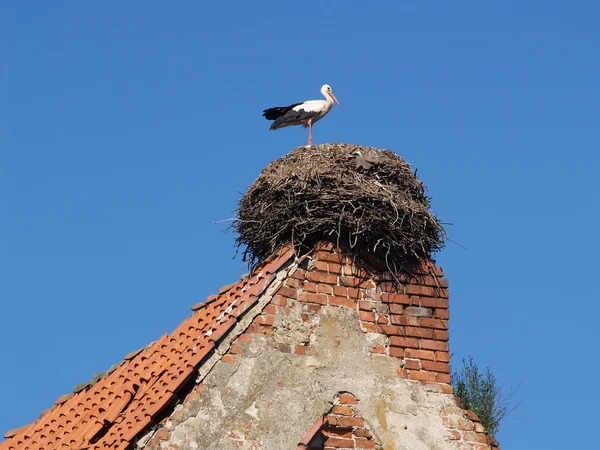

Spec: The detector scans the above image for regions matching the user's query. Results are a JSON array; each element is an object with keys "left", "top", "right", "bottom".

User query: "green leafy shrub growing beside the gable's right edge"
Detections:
[{"left": 452, "top": 356, "right": 520, "bottom": 436}]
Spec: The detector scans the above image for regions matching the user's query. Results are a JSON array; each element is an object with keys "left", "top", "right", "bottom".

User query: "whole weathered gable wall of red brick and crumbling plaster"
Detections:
[{"left": 140, "top": 244, "right": 499, "bottom": 450}]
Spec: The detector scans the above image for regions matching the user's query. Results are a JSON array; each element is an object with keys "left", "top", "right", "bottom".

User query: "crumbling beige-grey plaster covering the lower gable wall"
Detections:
[{"left": 150, "top": 302, "right": 470, "bottom": 450}]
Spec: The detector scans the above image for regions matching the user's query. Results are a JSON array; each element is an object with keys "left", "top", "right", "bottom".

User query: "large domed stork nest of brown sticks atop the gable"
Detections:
[{"left": 232, "top": 144, "right": 445, "bottom": 274}]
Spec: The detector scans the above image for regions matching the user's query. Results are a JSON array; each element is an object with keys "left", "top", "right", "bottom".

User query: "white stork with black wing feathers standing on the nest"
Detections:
[{"left": 263, "top": 84, "right": 340, "bottom": 145}]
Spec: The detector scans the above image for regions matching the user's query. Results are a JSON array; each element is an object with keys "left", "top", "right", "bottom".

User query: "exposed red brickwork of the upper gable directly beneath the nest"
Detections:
[{"left": 248, "top": 244, "right": 450, "bottom": 384}]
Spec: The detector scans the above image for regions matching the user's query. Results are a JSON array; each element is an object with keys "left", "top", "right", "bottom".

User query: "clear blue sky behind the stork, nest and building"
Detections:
[{"left": 0, "top": 0, "right": 600, "bottom": 450}]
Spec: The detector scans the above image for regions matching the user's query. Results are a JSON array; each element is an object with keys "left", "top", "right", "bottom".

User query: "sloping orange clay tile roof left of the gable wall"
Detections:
[{"left": 0, "top": 248, "right": 294, "bottom": 450}]
